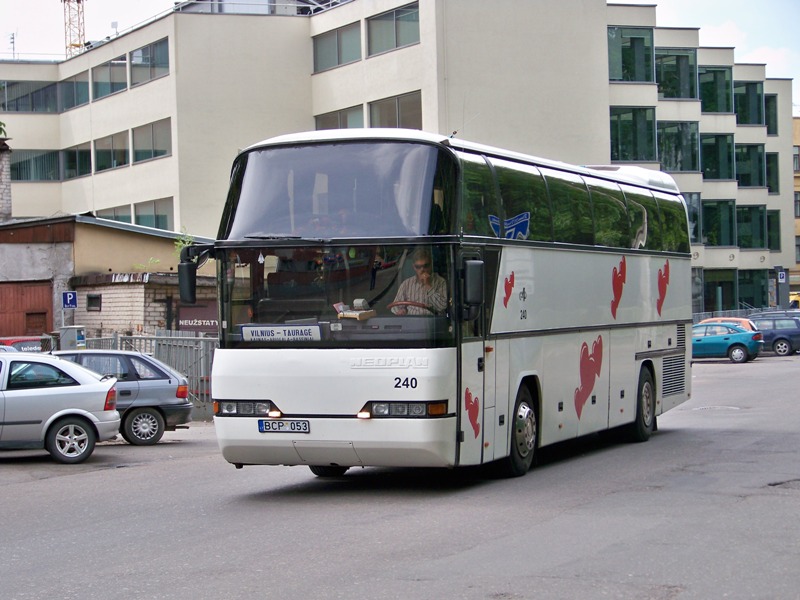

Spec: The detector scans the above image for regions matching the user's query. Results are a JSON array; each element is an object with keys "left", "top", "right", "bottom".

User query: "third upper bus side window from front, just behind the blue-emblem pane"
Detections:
[{"left": 541, "top": 168, "right": 594, "bottom": 245}]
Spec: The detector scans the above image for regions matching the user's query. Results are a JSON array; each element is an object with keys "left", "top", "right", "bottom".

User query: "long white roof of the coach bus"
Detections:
[{"left": 244, "top": 127, "right": 680, "bottom": 193}]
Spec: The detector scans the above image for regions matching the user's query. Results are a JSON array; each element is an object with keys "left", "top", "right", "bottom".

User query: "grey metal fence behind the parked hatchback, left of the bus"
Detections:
[{"left": 86, "top": 331, "right": 219, "bottom": 421}]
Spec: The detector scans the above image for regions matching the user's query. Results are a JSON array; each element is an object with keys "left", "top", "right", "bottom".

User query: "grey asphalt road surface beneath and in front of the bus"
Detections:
[{"left": 0, "top": 356, "right": 800, "bottom": 600}]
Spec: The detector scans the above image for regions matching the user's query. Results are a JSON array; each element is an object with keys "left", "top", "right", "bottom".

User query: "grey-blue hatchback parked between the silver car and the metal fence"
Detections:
[{"left": 53, "top": 350, "right": 192, "bottom": 446}]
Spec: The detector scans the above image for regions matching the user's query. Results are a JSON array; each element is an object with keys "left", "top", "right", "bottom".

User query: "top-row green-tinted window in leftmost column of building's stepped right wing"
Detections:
[{"left": 608, "top": 27, "right": 655, "bottom": 83}]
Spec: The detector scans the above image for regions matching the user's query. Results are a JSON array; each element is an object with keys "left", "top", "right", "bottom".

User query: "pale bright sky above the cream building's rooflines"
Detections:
[{"left": 0, "top": 0, "right": 800, "bottom": 116}]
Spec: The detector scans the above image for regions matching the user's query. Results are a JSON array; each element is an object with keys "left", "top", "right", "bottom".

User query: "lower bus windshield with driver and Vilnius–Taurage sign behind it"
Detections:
[{"left": 217, "top": 245, "right": 455, "bottom": 348}]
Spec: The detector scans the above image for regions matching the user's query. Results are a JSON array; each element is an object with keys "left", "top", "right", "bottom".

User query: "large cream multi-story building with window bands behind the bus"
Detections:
[{"left": 0, "top": 0, "right": 795, "bottom": 324}]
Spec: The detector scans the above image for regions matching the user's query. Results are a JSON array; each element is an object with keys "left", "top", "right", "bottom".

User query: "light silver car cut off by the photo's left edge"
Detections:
[{"left": 0, "top": 352, "right": 120, "bottom": 463}]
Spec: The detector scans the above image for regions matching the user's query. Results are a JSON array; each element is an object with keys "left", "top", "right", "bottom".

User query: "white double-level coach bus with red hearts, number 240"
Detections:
[{"left": 179, "top": 129, "right": 692, "bottom": 477}]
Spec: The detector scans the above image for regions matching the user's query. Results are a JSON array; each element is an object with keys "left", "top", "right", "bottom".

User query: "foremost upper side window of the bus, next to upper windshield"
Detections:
[{"left": 459, "top": 153, "right": 502, "bottom": 237}]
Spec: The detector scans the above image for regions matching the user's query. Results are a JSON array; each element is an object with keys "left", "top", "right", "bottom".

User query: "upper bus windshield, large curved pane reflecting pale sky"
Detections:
[{"left": 219, "top": 141, "right": 456, "bottom": 240}]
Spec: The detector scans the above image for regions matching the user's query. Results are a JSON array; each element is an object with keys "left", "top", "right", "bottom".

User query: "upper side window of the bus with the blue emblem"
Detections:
[{"left": 491, "top": 159, "right": 553, "bottom": 242}]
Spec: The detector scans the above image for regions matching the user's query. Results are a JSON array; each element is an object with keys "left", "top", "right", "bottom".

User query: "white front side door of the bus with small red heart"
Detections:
[{"left": 458, "top": 249, "right": 495, "bottom": 465}]
